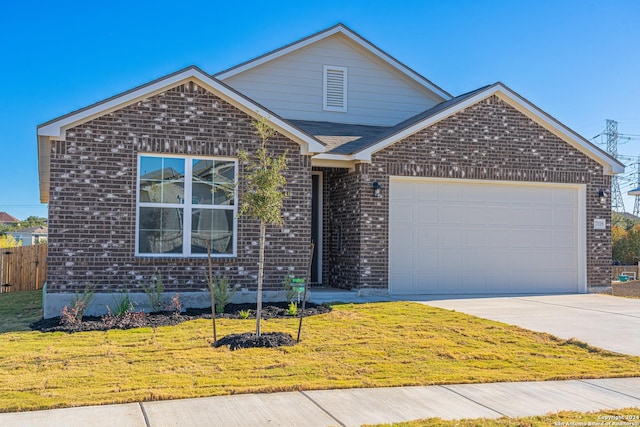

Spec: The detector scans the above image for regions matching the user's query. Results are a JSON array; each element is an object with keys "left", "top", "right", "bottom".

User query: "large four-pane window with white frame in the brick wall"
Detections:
[{"left": 136, "top": 154, "right": 237, "bottom": 257}]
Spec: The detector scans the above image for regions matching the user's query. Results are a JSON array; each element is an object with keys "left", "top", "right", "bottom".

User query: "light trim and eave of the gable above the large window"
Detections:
[{"left": 37, "top": 66, "right": 325, "bottom": 203}]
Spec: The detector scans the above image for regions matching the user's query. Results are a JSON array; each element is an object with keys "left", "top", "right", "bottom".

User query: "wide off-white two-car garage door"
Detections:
[{"left": 389, "top": 177, "right": 585, "bottom": 294}]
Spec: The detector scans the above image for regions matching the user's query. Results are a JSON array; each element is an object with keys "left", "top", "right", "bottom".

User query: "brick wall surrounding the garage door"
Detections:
[{"left": 329, "top": 96, "right": 611, "bottom": 288}]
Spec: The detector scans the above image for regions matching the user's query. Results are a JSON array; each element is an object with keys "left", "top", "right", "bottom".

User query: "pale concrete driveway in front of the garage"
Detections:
[{"left": 416, "top": 294, "right": 640, "bottom": 356}]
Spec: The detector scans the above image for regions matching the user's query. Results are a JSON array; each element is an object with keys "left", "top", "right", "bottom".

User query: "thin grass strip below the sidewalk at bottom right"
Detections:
[{"left": 368, "top": 408, "right": 640, "bottom": 427}]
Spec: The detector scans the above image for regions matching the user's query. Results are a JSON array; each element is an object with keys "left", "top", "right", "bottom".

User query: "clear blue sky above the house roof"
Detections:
[{"left": 0, "top": 0, "right": 640, "bottom": 219}]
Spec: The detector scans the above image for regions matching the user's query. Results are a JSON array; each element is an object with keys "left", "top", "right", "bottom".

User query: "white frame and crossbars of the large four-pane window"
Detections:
[{"left": 135, "top": 153, "right": 238, "bottom": 258}]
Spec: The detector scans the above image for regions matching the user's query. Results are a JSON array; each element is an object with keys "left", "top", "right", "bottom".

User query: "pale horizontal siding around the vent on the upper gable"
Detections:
[{"left": 225, "top": 35, "right": 442, "bottom": 126}]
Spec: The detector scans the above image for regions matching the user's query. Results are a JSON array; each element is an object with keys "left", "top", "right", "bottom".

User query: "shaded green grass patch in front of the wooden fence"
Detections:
[{"left": 0, "top": 290, "right": 42, "bottom": 333}]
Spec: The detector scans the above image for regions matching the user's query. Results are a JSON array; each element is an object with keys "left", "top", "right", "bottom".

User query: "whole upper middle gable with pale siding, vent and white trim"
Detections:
[{"left": 216, "top": 24, "right": 451, "bottom": 126}]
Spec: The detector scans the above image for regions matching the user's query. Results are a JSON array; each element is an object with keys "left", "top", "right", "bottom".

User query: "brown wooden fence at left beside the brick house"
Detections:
[{"left": 0, "top": 244, "right": 47, "bottom": 292}]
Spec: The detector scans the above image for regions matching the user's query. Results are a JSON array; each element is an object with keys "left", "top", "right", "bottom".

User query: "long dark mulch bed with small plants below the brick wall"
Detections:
[{"left": 30, "top": 302, "right": 331, "bottom": 335}]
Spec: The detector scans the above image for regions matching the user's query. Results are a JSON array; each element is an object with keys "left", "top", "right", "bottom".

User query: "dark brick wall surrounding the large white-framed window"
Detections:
[{"left": 47, "top": 83, "right": 311, "bottom": 293}]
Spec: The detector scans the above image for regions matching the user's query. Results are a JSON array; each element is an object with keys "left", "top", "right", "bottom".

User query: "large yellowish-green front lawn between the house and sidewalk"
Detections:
[{"left": 0, "top": 292, "right": 640, "bottom": 411}]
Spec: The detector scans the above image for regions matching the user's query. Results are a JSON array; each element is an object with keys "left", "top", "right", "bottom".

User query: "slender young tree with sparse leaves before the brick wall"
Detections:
[{"left": 238, "top": 117, "right": 288, "bottom": 336}]
